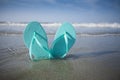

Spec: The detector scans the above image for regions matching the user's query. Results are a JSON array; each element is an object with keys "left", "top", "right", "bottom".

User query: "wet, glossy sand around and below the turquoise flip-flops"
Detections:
[{"left": 0, "top": 35, "right": 120, "bottom": 80}]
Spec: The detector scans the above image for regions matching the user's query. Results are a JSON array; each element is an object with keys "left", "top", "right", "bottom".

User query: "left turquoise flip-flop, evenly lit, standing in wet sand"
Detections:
[{"left": 24, "top": 22, "right": 51, "bottom": 60}]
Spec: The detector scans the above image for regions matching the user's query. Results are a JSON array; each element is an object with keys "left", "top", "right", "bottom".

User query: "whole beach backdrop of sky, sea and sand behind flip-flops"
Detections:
[{"left": 0, "top": 0, "right": 120, "bottom": 80}]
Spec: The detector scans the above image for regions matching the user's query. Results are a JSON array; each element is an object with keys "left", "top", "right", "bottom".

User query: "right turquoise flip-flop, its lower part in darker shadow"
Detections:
[{"left": 50, "top": 23, "right": 76, "bottom": 58}]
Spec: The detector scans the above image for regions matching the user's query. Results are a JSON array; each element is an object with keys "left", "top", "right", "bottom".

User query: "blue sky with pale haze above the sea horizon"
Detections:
[{"left": 0, "top": 0, "right": 120, "bottom": 23}]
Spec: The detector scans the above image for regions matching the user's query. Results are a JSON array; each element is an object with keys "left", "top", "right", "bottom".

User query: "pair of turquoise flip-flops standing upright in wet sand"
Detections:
[{"left": 24, "top": 22, "right": 76, "bottom": 60}]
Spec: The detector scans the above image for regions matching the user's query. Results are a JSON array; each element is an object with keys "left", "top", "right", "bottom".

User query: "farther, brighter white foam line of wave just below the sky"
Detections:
[{"left": 0, "top": 22, "right": 120, "bottom": 28}]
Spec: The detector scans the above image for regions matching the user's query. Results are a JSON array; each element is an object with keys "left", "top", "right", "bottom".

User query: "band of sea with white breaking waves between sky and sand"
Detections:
[{"left": 0, "top": 22, "right": 120, "bottom": 36}]
